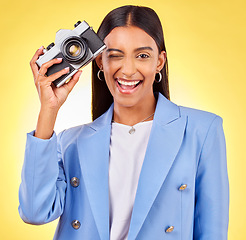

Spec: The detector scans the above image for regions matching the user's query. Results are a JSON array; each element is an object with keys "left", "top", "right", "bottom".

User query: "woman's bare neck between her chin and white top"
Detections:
[{"left": 113, "top": 96, "right": 156, "bottom": 126}]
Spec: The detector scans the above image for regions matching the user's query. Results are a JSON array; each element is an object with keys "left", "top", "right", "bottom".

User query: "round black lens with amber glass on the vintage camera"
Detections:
[{"left": 61, "top": 37, "right": 88, "bottom": 63}]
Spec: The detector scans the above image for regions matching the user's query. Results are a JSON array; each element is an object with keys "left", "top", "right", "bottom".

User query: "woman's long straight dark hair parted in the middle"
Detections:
[{"left": 92, "top": 5, "right": 170, "bottom": 120}]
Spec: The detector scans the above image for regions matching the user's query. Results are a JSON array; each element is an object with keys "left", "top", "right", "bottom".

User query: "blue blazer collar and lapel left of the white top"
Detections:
[{"left": 77, "top": 105, "right": 113, "bottom": 240}]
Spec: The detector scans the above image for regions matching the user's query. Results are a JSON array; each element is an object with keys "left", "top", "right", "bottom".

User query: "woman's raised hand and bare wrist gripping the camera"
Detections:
[{"left": 30, "top": 47, "right": 81, "bottom": 139}]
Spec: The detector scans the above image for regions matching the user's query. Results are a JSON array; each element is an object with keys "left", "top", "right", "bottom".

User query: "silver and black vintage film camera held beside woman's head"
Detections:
[{"left": 36, "top": 21, "right": 106, "bottom": 87}]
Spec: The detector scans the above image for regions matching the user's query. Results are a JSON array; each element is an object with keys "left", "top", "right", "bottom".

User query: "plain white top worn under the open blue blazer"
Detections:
[{"left": 109, "top": 121, "right": 153, "bottom": 240}]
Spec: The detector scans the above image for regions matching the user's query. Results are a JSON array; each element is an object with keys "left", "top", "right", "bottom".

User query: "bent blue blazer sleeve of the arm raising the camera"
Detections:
[{"left": 18, "top": 132, "right": 66, "bottom": 224}]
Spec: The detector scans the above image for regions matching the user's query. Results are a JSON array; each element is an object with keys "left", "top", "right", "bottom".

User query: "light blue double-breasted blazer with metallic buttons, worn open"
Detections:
[{"left": 19, "top": 94, "right": 229, "bottom": 240}]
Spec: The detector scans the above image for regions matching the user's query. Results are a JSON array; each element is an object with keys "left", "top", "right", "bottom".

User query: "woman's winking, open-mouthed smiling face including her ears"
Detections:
[{"left": 97, "top": 26, "right": 165, "bottom": 107}]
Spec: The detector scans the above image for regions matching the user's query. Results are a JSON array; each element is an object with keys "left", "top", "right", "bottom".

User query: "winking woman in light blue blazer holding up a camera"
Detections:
[{"left": 19, "top": 6, "right": 229, "bottom": 240}]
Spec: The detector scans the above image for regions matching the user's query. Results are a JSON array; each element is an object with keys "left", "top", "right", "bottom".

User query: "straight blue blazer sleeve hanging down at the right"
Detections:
[{"left": 194, "top": 116, "right": 229, "bottom": 240}]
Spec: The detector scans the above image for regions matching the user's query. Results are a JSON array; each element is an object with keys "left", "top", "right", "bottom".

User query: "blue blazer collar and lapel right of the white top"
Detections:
[{"left": 128, "top": 94, "right": 186, "bottom": 240}]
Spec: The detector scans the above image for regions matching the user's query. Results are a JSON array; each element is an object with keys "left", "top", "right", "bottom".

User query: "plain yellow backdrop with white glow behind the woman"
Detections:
[{"left": 0, "top": 0, "right": 246, "bottom": 240}]
